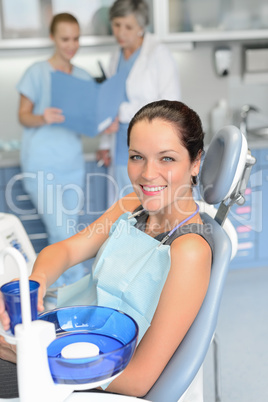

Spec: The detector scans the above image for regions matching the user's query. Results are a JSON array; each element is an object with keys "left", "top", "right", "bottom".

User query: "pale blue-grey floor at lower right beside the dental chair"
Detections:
[{"left": 204, "top": 267, "right": 268, "bottom": 402}]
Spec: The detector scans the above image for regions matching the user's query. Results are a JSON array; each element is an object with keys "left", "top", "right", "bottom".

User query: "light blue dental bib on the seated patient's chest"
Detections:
[{"left": 58, "top": 213, "right": 170, "bottom": 341}]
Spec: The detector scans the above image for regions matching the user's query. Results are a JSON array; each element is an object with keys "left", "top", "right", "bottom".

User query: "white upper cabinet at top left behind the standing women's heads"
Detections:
[{"left": 0, "top": 0, "right": 153, "bottom": 49}]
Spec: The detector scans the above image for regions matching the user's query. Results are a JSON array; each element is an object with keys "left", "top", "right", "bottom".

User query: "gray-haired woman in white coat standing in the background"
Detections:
[{"left": 97, "top": 0, "right": 181, "bottom": 205}]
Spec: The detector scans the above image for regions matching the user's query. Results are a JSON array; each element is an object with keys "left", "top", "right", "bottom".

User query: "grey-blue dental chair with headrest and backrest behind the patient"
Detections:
[{"left": 144, "top": 126, "right": 256, "bottom": 402}]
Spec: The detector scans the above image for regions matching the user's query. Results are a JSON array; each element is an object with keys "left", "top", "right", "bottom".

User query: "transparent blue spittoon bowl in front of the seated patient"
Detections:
[{"left": 38, "top": 306, "right": 138, "bottom": 384}]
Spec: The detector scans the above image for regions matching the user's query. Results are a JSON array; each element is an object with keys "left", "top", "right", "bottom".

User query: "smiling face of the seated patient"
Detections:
[{"left": 128, "top": 119, "right": 200, "bottom": 213}]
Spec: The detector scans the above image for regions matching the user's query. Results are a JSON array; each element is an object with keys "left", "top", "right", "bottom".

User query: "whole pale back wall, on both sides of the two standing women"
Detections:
[{"left": 0, "top": 42, "right": 268, "bottom": 149}]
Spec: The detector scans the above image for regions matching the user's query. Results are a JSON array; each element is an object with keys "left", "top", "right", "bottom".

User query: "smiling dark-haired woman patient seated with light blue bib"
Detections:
[{"left": 0, "top": 100, "right": 213, "bottom": 401}]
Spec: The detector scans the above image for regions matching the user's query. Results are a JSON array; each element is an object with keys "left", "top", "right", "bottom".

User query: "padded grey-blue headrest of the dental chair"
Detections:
[{"left": 200, "top": 125, "right": 248, "bottom": 204}]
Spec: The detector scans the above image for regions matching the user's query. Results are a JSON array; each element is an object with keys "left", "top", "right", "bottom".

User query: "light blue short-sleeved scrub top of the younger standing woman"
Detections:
[{"left": 17, "top": 61, "right": 92, "bottom": 185}]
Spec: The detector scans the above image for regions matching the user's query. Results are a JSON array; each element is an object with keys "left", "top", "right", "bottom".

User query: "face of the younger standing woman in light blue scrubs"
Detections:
[{"left": 51, "top": 22, "right": 80, "bottom": 61}]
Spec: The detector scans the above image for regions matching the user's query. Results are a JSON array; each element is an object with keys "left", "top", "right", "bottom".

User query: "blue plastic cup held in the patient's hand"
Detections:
[{"left": 0, "top": 281, "right": 40, "bottom": 334}]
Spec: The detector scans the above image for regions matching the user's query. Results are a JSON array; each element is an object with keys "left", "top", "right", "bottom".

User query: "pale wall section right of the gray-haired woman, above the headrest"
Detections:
[{"left": 171, "top": 42, "right": 268, "bottom": 142}]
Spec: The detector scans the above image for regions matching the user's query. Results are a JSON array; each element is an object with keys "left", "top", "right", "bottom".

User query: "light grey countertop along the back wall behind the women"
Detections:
[{"left": 0, "top": 135, "right": 268, "bottom": 168}]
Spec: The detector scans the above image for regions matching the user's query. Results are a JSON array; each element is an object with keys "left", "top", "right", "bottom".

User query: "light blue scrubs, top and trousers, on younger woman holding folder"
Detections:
[{"left": 17, "top": 61, "right": 92, "bottom": 287}]
